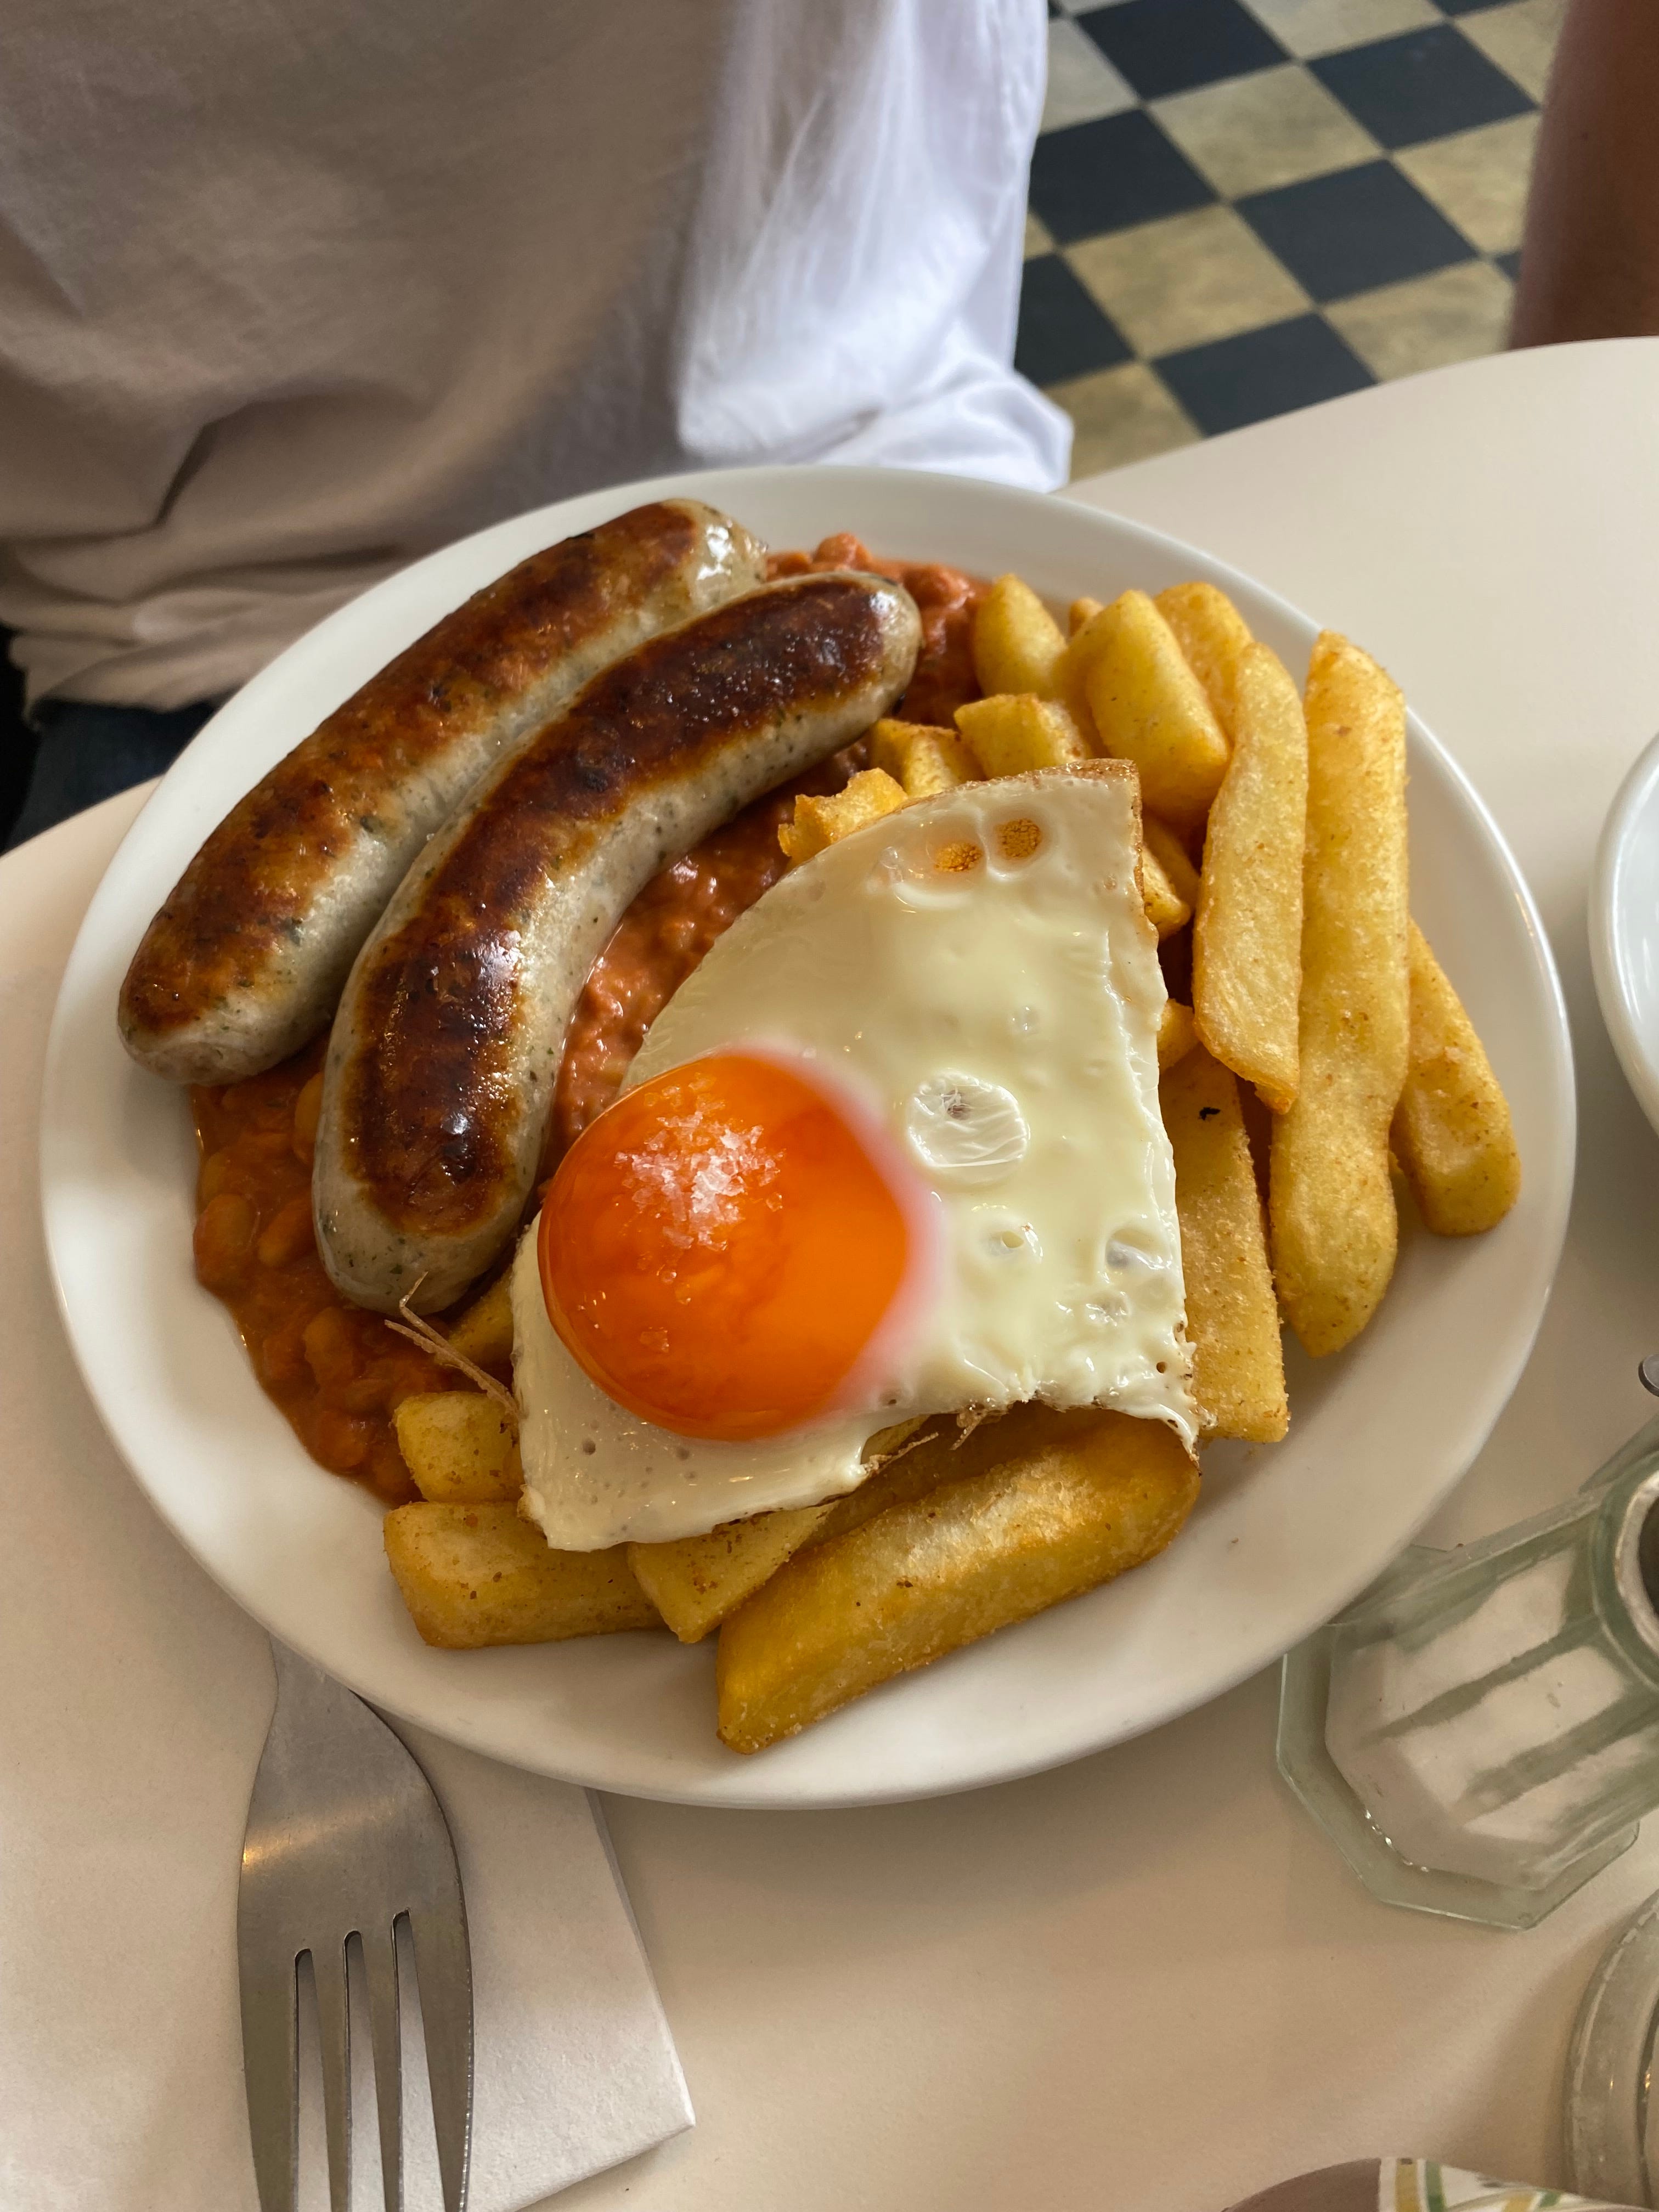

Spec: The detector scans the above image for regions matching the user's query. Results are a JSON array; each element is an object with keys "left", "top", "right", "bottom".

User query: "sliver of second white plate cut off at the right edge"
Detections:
[{"left": 1590, "top": 737, "right": 1659, "bottom": 1128}]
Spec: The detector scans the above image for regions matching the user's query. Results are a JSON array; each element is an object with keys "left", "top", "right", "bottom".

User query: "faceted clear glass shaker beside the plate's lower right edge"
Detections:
[{"left": 1278, "top": 1407, "right": 1659, "bottom": 1929}]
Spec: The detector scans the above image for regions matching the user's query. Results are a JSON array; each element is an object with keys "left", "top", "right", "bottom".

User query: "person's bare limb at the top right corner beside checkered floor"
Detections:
[{"left": 1511, "top": 0, "right": 1659, "bottom": 345}]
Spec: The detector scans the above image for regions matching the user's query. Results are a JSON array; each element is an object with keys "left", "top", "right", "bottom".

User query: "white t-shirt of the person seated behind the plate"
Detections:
[{"left": 0, "top": 0, "right": 1070, "bottom": 706}]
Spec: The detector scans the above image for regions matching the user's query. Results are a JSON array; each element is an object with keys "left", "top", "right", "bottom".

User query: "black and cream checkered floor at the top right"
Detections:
[{"left": 1035, "top": 0, "right": 1566, "bottom": 476}]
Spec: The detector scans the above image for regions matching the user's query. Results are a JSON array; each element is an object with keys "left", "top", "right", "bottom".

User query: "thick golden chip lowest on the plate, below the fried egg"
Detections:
[{"left": 716, "top": 1409, "right": 1199, "bottom": 1752}]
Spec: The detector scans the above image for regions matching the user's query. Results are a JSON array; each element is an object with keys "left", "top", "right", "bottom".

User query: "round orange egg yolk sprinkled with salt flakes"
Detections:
[{"left": 538, "top": 1053, "right": 909, "bottom": 1442}]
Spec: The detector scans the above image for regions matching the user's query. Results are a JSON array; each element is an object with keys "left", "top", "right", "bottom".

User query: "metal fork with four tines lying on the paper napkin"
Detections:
[{"left": 236, "top": 1637, "right": 473, "bottom": 2212}]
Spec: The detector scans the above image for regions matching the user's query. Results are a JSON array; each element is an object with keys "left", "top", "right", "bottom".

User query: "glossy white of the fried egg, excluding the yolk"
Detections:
[{"left": 513, "top": 763, "right": 1197, "bottom": 1550}]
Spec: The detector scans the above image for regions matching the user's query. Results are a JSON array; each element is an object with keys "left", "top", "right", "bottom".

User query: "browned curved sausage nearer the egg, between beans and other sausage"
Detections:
[{"left": 312, "top": 571, "right": 920, "bottom": 1314}]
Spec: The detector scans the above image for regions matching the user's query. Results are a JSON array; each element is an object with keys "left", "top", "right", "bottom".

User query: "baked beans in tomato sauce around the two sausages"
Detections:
[{"left": 190, "top": 533, "right": 984, "bottom": 1504}]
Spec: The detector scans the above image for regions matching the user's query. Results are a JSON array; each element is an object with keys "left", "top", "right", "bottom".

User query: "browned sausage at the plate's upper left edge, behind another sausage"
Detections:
[{"left": 120, "top": 500, "right": 765, "bottom": 1084}]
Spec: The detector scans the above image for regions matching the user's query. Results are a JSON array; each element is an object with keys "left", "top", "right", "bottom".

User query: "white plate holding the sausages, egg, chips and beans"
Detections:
[{"left": 42, "top": 469, "right": 1573, "bottom": 1805}]
